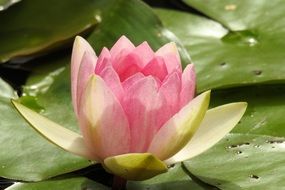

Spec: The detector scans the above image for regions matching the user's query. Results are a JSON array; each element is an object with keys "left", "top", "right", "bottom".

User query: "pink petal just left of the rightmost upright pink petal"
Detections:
[{"left": 159, "top": 72, "right": 181, "bottom": 116}]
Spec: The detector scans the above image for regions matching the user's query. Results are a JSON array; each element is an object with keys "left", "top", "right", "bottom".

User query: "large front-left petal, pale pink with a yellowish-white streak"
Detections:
[{"left": 79, "top": 75, "right": 130, "bottom": 161}]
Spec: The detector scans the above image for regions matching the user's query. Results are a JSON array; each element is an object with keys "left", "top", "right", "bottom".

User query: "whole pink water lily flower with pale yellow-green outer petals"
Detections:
[{"left": 13, "top": 36, "right": 246, "bottom": 180}]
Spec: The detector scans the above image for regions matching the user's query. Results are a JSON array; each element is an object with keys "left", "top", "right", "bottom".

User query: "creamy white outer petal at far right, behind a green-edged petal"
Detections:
[{"left": 165, "top": 102, "right": 247, "bottom": 164}]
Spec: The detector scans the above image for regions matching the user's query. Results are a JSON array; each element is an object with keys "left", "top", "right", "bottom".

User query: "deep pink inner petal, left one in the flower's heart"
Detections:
[{"left": 112, "top": 53, "right": 141, "bottom": 81}]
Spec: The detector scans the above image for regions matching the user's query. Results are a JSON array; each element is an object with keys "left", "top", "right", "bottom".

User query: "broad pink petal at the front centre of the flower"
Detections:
[{"left": 122, "top": 77, "right": 165, "bottom": 152}]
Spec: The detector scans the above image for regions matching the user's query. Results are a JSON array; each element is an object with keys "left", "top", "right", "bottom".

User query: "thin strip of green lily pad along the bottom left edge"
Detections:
[{"left": 6, "top": 177, "right": 110, "bottom": 190}]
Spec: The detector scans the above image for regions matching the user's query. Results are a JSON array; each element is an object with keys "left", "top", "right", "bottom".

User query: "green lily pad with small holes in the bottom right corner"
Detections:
[{"left": 185, "top": 133, "right": 285, "bottom": 190}]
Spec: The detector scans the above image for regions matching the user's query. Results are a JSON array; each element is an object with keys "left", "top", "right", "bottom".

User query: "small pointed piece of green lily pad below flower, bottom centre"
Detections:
[{"left": 127, "top": 164, "right": 216, "bottom": 190}]
